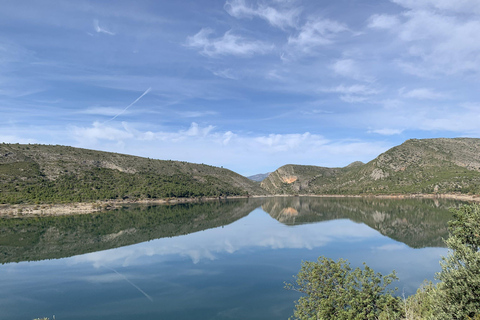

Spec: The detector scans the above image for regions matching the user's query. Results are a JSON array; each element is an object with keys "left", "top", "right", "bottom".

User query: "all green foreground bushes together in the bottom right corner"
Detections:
[{"left": 287, "top": 205, "right": 480, "bottom": 320}]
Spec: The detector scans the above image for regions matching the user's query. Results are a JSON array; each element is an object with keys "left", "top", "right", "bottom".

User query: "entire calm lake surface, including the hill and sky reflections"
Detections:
[{"left": 0, "top": 197, "right": 458, "bottom": 320}]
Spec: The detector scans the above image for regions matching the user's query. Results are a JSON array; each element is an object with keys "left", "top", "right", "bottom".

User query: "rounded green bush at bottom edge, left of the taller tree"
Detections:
[{"left": 286, "top": 257, "right": 402, "bottom": 320}]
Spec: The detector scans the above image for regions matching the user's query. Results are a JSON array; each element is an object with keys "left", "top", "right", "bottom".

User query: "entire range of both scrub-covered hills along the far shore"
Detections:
[{"left": 0, "top": 138, "right": 480, "bottom": 204}]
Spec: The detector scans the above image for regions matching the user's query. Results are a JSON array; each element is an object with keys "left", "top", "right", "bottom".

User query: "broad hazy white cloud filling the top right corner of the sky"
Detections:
[{"left": 369, "top": 0, "right": 480, "bottom": 78}]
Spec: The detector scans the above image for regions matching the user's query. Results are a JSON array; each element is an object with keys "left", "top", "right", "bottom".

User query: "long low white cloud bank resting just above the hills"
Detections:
[{"left": 69, "top": 122, "right": 386, "bottom": 174}]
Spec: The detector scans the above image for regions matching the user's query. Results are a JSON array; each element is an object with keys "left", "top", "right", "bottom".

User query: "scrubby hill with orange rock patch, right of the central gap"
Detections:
[{"left": 261, "top": 138, "right": 480, "bottom": 194}]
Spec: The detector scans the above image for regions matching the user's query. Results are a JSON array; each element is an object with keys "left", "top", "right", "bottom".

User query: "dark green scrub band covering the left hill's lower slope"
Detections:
[{"left": 0, "top": 164, "right": 248, "bottom": 204}]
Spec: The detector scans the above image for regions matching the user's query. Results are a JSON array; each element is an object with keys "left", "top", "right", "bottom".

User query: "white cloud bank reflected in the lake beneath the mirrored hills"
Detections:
[{"left": 69, "top": 209, "right": 382, "bottom": 268}]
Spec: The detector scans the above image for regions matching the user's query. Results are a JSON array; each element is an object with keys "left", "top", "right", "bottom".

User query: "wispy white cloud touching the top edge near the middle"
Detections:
[{"left": 224, "top": 0, "right": 301, "bottom": 29}]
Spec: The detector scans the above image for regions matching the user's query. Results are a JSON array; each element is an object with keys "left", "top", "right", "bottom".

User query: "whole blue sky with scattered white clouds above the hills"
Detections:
[{"left": 0, "top": 0, "right": 480, "bottom": 176}]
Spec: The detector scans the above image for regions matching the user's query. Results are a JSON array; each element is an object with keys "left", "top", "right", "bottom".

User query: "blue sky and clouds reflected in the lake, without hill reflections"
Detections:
[{"left": 0, "top": 209, "right": 446, "bottom": 319}]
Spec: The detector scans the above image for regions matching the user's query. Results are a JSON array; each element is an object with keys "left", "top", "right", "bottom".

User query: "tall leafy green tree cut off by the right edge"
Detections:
[{"left": 437, "top": 205, "right": 480, "bottom": 319}]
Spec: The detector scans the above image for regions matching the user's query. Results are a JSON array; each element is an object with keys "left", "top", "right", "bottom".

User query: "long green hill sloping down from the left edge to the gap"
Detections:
[{"left": 0, "top": 144, "right": 266, "bottom": 204}]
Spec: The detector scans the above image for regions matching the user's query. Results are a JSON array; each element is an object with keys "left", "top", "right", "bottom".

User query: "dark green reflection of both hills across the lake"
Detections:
[{"left": 0, "top": 197, "right": 464, "bottom": 263}]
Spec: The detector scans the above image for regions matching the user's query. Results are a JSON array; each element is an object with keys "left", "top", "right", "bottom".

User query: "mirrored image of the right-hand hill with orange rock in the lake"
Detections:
[{"left": 262, "top": 197, "right": 460, "bottom": 248}]
